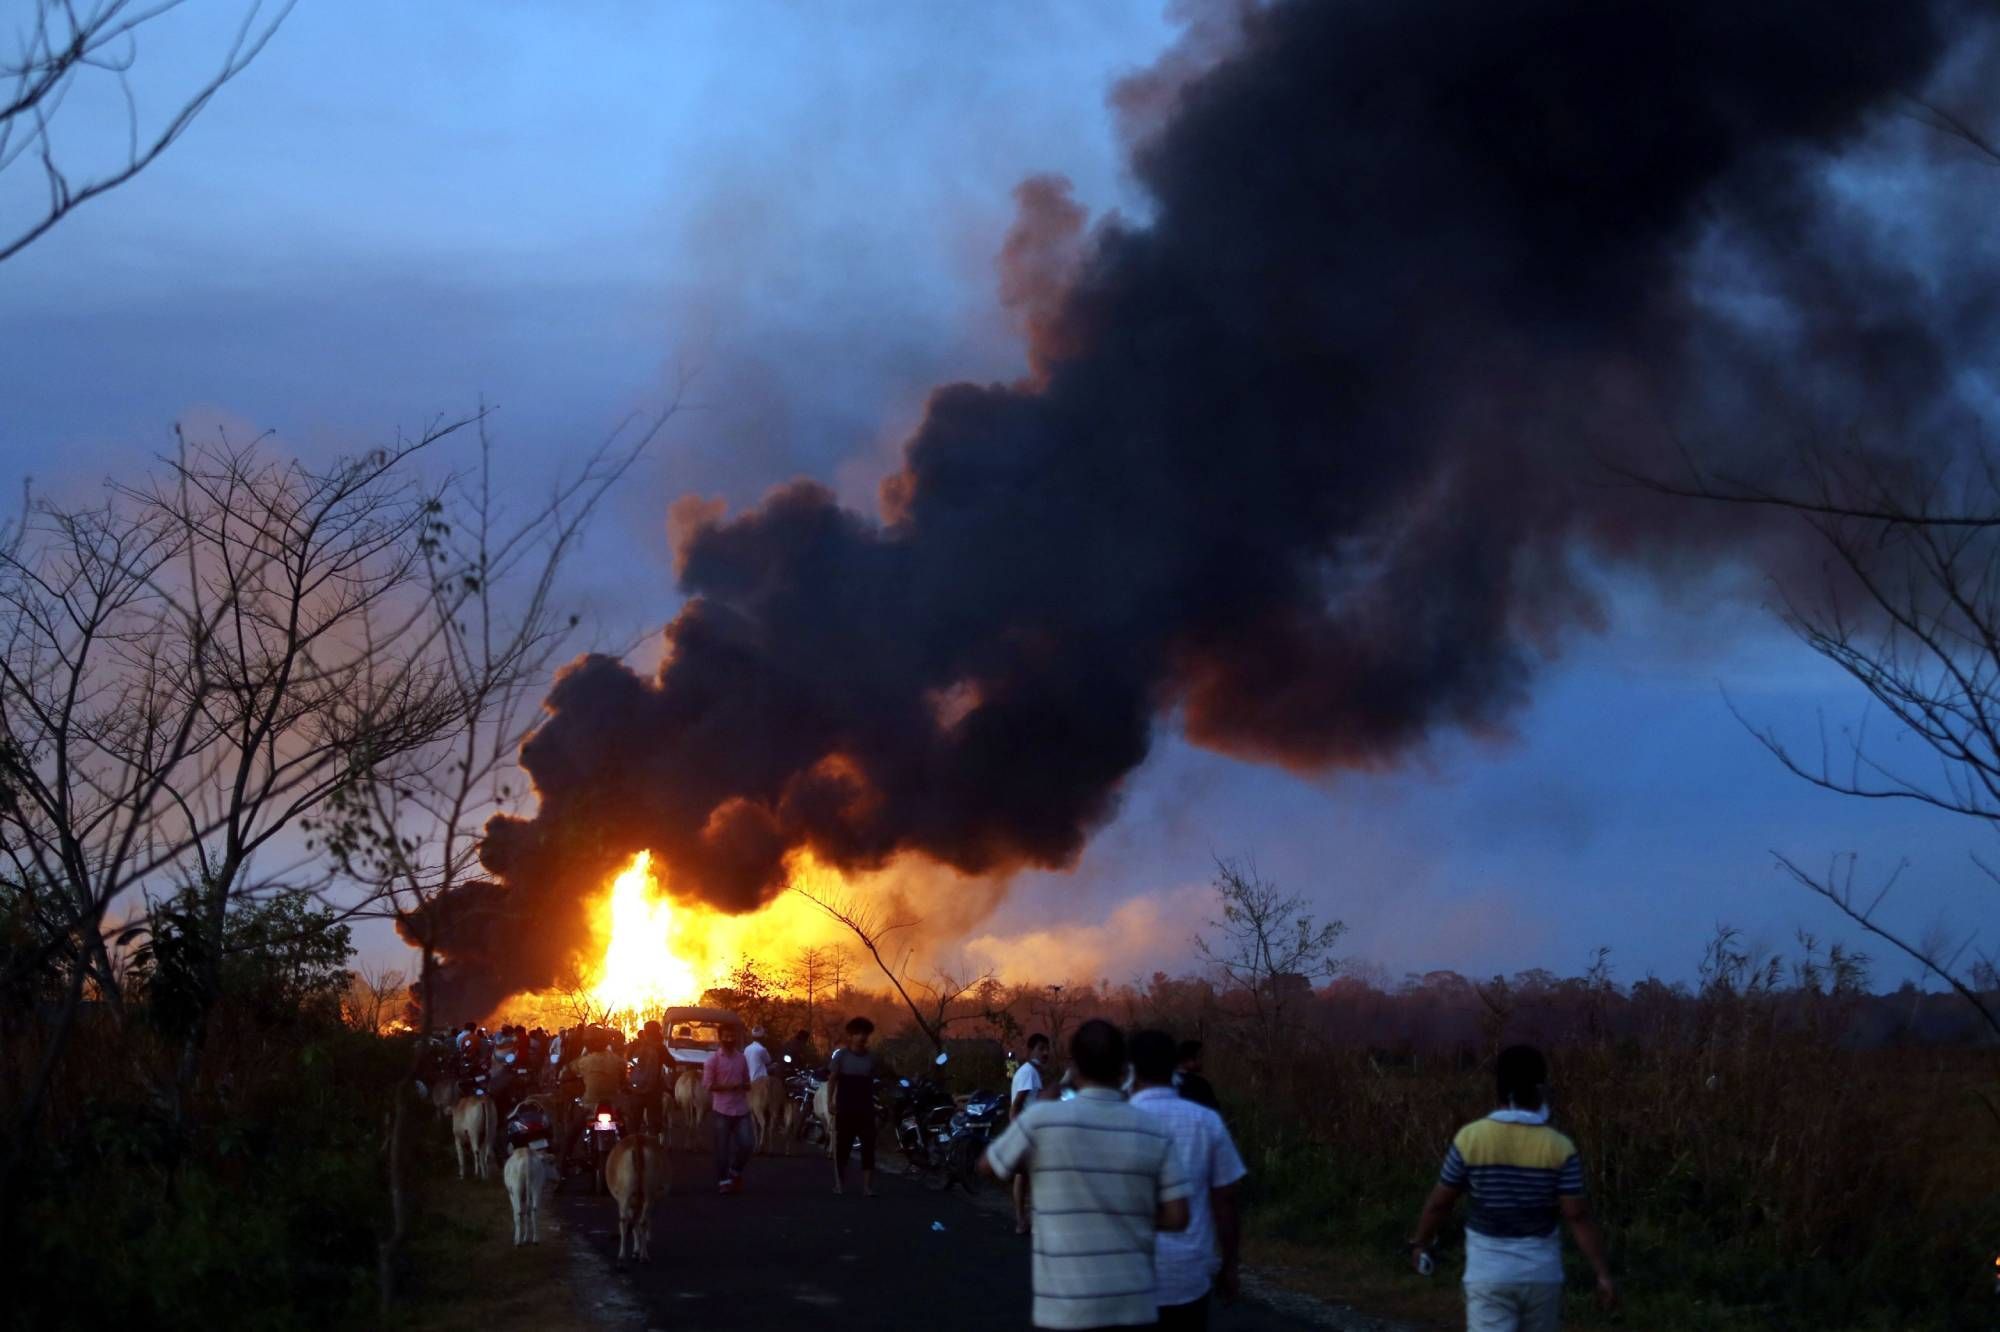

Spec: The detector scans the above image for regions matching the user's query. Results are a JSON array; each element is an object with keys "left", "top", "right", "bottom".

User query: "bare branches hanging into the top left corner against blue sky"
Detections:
[{"left": 0, "top": 0, "right": 296, "bottom": 262}]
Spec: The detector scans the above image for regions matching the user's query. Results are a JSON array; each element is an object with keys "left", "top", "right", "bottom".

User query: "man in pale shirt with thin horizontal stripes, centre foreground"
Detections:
[{"left": 980, "top": 1018, "right": 1192, "bottom": 1328}]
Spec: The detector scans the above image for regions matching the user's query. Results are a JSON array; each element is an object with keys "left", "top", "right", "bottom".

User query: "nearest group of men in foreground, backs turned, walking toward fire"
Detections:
[{"left": 980, "top": 1020, "right": 1618, "bottom": 1332}]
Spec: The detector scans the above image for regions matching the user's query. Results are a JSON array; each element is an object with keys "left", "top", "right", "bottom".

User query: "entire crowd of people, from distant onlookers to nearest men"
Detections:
[{"left": 454, "top": 1018, "right": 1618, "bottom": 1332}]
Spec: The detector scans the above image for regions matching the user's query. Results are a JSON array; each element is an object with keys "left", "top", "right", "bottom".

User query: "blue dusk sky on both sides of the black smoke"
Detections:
[{"left": 0, "top": 0, "right": 1986, "bottom": 984}]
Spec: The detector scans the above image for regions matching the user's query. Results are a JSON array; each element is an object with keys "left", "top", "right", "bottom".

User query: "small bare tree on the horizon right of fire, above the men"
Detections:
[{"left": 1194, "top": 860, "right": 1346, "bottom": 1072}]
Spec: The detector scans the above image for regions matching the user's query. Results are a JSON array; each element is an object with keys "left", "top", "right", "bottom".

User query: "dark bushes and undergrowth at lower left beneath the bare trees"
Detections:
[{"left": 0, "top": 892, "right": 398, "bottom": 1328}]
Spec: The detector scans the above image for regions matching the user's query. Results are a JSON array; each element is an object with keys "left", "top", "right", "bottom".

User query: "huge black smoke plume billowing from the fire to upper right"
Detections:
[{"left": 458, "top": 0, "right": 1994, "bottom": 1008}]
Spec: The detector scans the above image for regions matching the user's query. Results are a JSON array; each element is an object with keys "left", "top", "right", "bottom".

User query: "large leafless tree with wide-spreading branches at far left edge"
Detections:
[{"left": 0, "top": 422, "right": 464, "bottom": 1192}]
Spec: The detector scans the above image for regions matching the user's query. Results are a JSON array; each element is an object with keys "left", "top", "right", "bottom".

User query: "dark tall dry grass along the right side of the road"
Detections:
[{"left": 1208, "top": 976, "right": 2000, "bottom": 1328}]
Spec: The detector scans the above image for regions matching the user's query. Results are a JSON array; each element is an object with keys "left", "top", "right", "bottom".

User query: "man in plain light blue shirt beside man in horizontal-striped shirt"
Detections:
[{"left": 1132, "top": 1032, "right": 1248, "bottom": 1332}]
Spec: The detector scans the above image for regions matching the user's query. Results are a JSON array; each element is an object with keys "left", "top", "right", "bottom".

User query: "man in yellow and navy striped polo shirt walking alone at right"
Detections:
[{"left": 1410, "top": 1046, "right": 1618, "bottom": 1332}]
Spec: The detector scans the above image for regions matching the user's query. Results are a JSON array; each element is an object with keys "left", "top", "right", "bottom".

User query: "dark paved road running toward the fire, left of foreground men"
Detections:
[{"left": 556, "top": 1152, "right": 1312, "bottom": 1332}]
